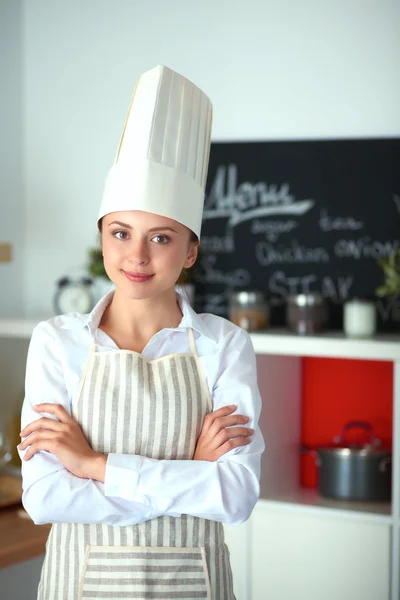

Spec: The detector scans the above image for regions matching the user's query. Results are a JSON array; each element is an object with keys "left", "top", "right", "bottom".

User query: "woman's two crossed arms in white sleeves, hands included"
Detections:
[{"left": 18, "top": 324, "right": 264, "bottom": 525}]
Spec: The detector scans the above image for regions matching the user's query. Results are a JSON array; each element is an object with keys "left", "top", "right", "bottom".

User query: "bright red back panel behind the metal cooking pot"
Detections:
[{"left": 301, "top": 358, "right": 393, "bottom": 487}]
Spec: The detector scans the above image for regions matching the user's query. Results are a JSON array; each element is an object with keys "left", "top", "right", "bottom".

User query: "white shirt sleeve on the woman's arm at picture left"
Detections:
[{"left": 18, "top": 322, "right": 151, "bottom": 525}]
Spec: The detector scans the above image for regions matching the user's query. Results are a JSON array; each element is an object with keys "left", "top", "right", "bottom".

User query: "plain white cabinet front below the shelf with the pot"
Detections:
[{"left": 249, "top": 505, "right": 391, "bottom": 600}]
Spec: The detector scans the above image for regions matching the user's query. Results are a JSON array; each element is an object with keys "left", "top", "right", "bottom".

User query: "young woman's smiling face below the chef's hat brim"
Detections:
[{"left": 101, "top": 210, "right": 198, "bottom": 299}]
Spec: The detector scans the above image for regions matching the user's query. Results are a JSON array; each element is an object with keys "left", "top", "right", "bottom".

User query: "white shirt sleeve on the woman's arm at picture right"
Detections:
[{"left": 104, "top": 328, "right": 264, "bottom": 524}]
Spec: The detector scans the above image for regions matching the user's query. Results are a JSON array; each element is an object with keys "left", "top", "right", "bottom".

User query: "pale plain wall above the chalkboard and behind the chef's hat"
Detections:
[{"left": 0, "top": 0, "right": 400, "bottom": 315}]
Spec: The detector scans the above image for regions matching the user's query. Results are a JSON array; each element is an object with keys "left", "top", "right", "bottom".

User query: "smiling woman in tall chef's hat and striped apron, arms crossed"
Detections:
[{"left": 19, "top": 67, "right": 264, "bottom": 600}]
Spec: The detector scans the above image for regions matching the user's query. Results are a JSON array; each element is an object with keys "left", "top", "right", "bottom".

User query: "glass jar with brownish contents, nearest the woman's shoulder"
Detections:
[{"left": 229, "top": 291, "right": 269, "bottom": 331}]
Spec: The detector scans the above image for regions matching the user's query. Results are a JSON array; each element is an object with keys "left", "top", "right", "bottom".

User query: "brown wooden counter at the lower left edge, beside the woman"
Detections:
[{"left": 0, "top": 504, "right": 51, "bottom": 568}]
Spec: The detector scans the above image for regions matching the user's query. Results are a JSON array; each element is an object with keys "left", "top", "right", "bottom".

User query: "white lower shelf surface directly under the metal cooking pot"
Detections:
[{"left": 258, "top": 488, "right": 394, "bottom": 525}]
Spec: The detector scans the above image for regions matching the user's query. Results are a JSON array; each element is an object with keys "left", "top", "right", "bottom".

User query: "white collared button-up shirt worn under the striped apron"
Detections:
[{"left": 19, "top": 291, "right": 264, "bottom": 525}]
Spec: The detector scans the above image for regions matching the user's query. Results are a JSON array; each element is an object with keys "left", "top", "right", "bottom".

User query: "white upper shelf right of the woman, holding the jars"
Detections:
[{"left": 251, "top": 329, "right": 400, "bottom": 361}]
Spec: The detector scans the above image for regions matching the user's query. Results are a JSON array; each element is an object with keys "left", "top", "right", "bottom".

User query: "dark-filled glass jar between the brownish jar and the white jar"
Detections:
[{"left": 286, "top": 294, "right": 327, "bottom": 335}]
